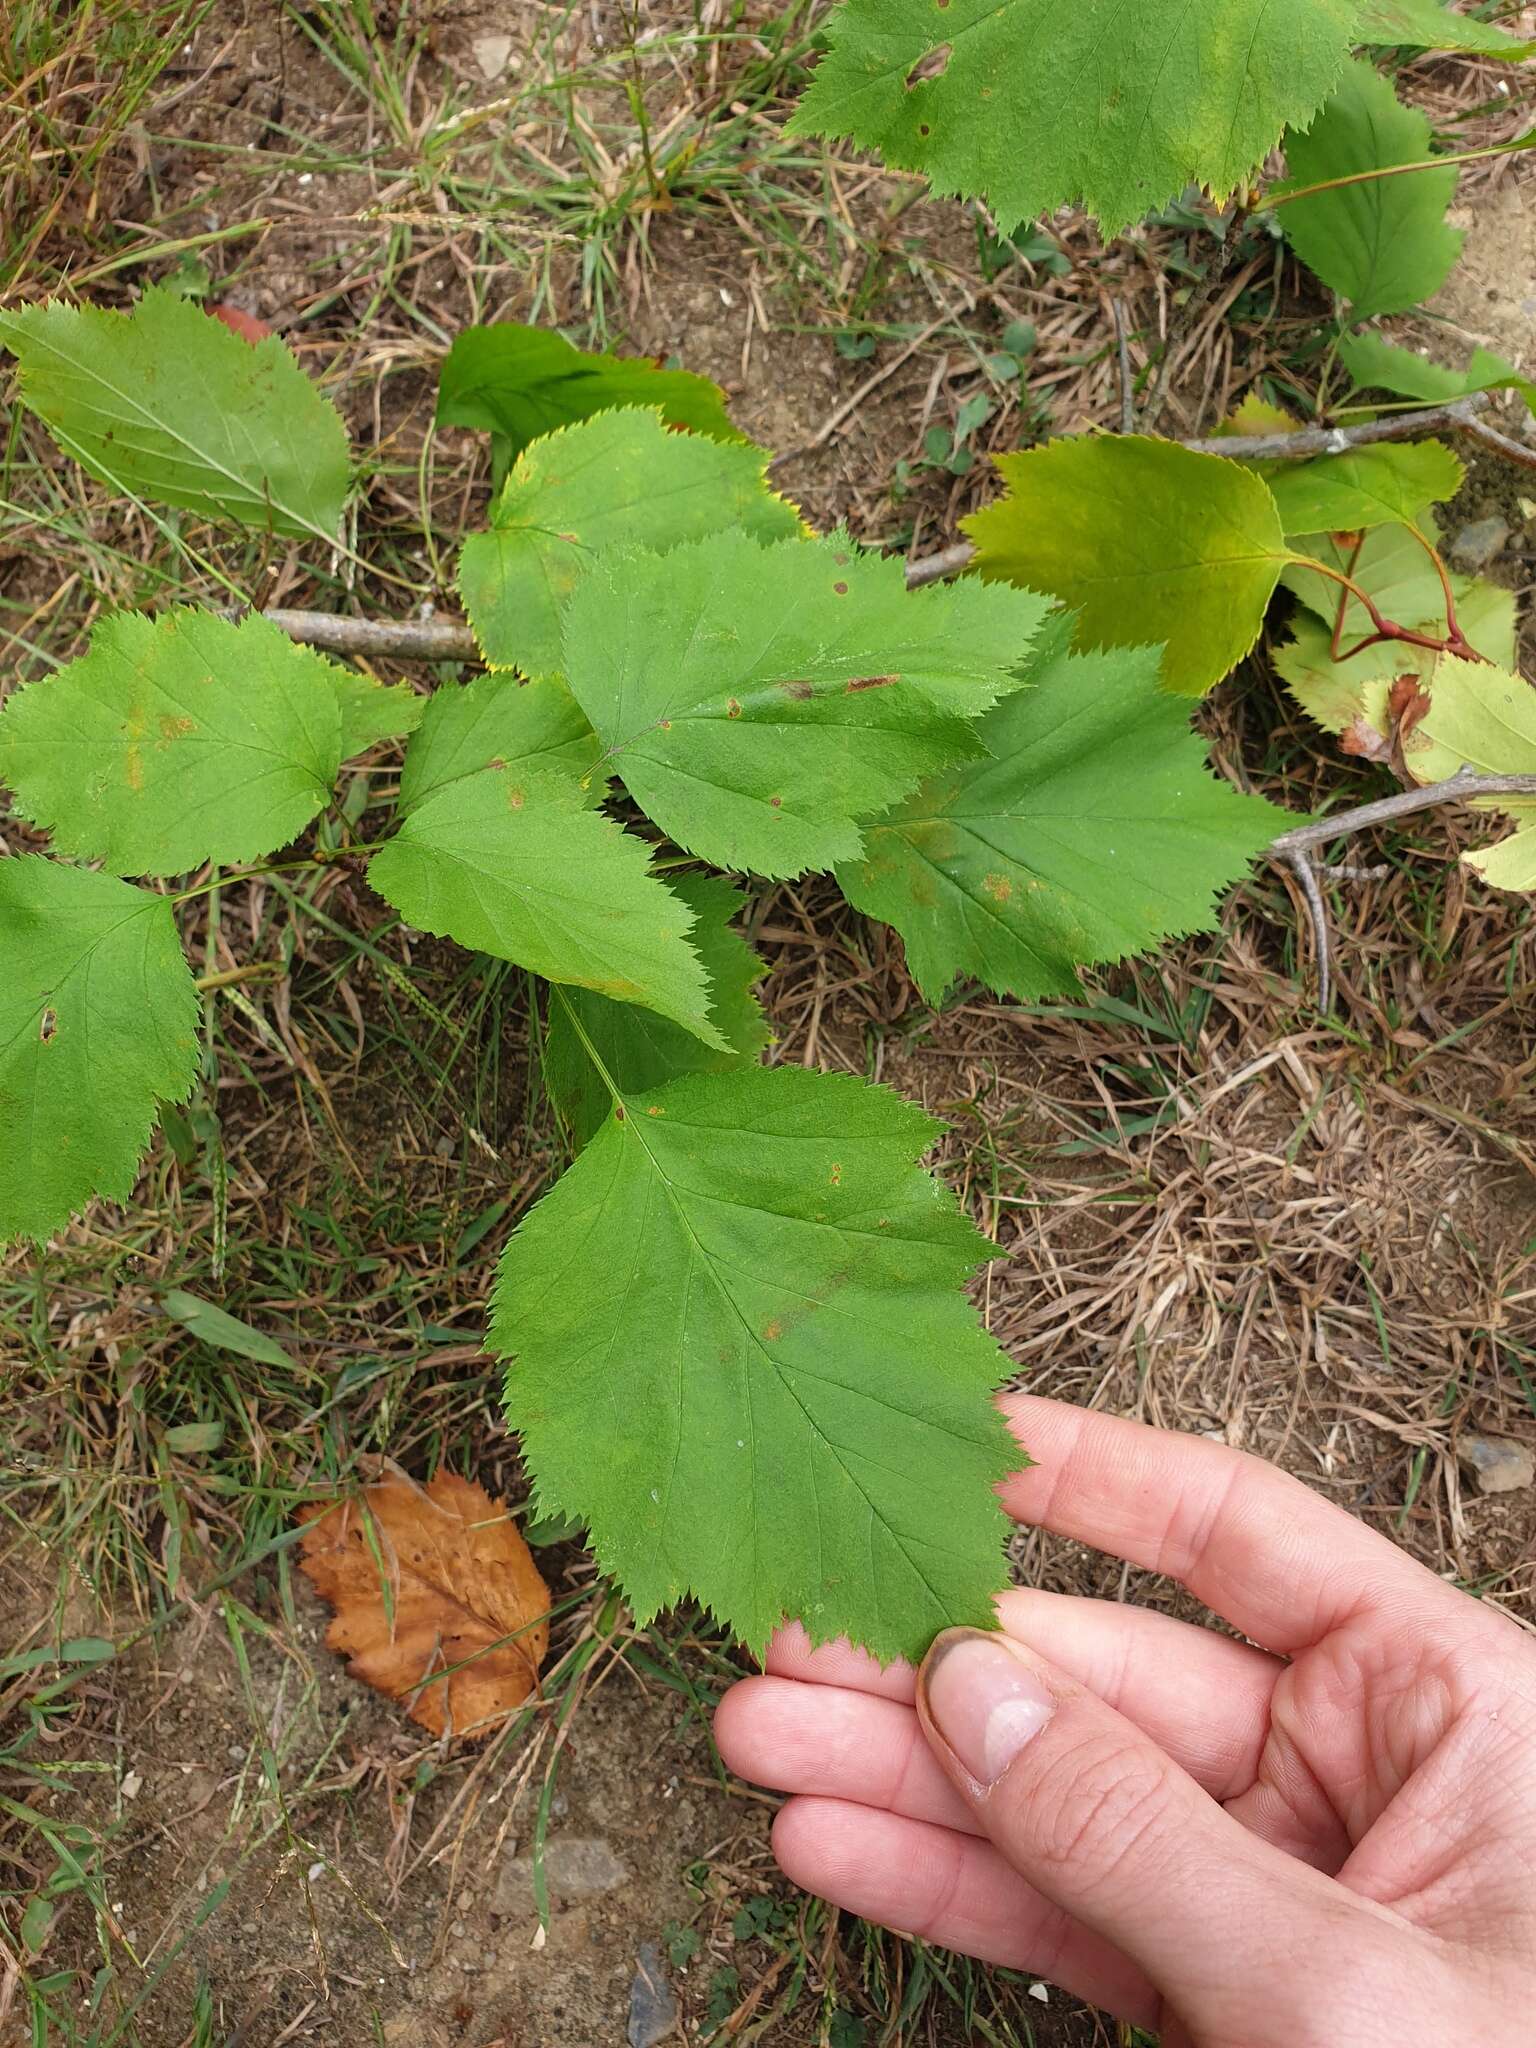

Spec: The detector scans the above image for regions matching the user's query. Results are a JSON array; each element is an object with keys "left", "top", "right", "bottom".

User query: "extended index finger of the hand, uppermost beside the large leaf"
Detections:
[{"left": 999, "top": 1395, "right": 1477, "bottom": 1655}]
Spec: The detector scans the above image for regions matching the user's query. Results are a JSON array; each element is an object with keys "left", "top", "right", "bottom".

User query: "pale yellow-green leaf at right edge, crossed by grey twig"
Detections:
[{"left": 1403, "top": 655, "right": 1536, "bottom": 889}]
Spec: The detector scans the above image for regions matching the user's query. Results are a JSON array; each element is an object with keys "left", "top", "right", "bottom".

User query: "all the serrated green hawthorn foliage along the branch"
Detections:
[{"left": 0, "top": 0, "right": 1536, "bottom": 1657}]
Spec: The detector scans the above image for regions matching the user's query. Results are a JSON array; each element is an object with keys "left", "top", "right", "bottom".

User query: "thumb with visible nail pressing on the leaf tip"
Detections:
[{"left": 918, "top": 1628, "right": 1354, "bottom": 2038}]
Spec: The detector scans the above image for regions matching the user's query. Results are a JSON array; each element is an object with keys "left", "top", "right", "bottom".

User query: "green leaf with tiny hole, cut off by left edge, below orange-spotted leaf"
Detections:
[{"left": 0, "top": 854, "right": 199, "bottom": 1243}]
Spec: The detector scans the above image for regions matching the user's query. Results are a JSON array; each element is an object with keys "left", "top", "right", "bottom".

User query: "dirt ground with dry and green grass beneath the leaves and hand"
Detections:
[{"left": 0, "top": 0, "right": 1536, "bottom": 2048}]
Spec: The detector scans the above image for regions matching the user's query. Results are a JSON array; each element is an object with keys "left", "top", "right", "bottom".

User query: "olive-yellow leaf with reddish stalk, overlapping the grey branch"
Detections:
[{"left": 961, "top": 434, "right": 1290, "bottom": 696}]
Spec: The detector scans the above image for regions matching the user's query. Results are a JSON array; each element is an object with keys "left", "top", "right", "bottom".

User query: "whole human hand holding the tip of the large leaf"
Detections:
[{"left": 715, "top": 1395, "right": 1536, "bottom": 2048}]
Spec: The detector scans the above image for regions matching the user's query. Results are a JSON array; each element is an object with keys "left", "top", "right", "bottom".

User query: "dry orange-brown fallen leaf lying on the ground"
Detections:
[{"left": 297, "top": 1470, "right": 549, "bottom": 1737}]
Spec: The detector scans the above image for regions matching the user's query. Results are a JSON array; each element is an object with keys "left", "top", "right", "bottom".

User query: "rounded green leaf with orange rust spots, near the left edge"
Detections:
[{"left": 0, "top": 610, "right": 342, "bottom": 874}]
